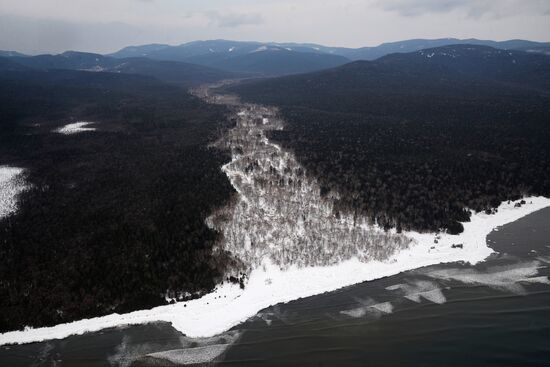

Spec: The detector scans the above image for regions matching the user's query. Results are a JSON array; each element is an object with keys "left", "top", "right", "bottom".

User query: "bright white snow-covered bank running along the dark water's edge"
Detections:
[{"left": 0, "top": 197, "right": 550, "bottom": 345}]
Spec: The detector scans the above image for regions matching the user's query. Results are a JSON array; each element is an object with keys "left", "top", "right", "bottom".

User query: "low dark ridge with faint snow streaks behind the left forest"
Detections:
[{"left": 0, "top": 51, "right": 241, "bottom": 87}]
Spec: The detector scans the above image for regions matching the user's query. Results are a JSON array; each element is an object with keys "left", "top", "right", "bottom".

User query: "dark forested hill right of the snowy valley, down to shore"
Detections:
[{"left": 232, "top": 45, "right": 550, "bottom": 236}]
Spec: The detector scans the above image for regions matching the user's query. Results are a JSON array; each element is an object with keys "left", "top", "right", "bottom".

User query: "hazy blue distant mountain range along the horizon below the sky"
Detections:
[{"left": 0, "top": 38, "right": 550, "bottom": 79}]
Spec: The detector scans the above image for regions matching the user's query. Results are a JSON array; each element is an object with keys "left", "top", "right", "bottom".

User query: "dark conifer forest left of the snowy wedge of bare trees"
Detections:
[{"left": 0, "top": 70, "right": 233, "bottom": 332}]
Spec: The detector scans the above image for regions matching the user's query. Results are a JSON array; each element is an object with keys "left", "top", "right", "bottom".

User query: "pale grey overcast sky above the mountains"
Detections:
[{"left": 0, "top": 0, "right": 550, "bottom": 53}]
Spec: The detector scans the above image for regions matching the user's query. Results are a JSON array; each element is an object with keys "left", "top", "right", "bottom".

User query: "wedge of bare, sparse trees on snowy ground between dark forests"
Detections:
[{"left": 207, "top": 105, "right": 413, "bottom": 273}]
